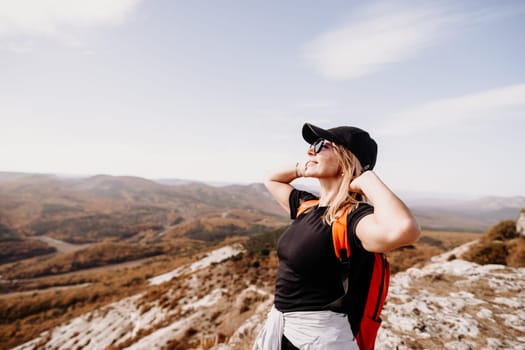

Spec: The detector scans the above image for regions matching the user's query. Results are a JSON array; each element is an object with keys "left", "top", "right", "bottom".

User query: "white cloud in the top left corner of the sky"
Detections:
[{"left": 0, "top": 0, "right": 140, "bottom": 45}]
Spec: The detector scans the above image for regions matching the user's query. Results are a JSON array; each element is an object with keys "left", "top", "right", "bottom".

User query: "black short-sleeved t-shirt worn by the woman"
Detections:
[{"left": 274, "top": 189, "right": 373, "bottom": 312}]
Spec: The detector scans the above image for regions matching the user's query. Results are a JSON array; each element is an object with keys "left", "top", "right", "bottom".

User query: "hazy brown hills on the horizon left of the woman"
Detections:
[{"left": 0, "top": 173, "right": 288, "bottom": 250}]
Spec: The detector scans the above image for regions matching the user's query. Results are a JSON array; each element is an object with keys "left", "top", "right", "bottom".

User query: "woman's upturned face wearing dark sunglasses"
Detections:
[{"left": 305, "top": 140, "right": 341, "bottom": 179}]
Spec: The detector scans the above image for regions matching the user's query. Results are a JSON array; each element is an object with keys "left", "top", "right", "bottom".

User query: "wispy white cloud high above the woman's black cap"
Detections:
[{"left": 302, "top": 2, "right": 512, "bottom": 80}]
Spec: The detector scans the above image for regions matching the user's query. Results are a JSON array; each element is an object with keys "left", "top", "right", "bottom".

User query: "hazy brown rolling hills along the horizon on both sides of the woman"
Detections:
[{"left": 0, "top": 172, "right": 525, "bottom": 261}]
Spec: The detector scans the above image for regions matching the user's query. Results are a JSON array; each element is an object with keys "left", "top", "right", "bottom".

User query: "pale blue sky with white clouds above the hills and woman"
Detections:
[{"left": 0, "top": 0, "right": 525, "bottom": 196}]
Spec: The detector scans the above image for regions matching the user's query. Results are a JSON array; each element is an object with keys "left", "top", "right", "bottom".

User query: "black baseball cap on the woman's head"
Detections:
[{"left": 303, "top": 123, "right": 377, "bottom": 171}]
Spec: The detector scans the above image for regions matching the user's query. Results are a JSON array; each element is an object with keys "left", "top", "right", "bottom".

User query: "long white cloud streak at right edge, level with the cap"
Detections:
[{"left": 378, "top": 84, "right": 525, "bottom": 134}]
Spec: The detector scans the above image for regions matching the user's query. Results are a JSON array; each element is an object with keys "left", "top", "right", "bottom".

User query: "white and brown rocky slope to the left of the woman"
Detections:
[{"left": 14, "top": 245, "right": 274, "bottom": 349}]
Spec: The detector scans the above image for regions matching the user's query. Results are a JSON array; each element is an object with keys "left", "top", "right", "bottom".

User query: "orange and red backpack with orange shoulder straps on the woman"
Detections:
[{"left": 297, "top": 200, "right": 390, "bottom": 350}]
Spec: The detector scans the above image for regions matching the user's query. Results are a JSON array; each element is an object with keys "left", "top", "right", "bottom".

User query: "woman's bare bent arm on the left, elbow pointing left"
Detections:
[{"left": 264, "top": 163, "right": 304, "bottom": 214}]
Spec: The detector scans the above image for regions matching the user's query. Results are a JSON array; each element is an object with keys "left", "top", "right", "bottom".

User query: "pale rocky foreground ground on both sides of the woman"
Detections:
[{"left": 12, "top": 242, "right": 525, "bottom": 350}]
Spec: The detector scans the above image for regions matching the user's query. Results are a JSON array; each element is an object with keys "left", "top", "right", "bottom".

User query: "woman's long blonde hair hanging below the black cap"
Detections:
[{"left": 323, "top": 144, "right": 364, "bottom": 225}]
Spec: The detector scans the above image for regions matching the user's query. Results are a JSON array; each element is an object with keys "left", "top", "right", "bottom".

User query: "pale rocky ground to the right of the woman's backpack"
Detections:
[{"left": 237, "top": 241, "right": 525, "bottom": 350}]
